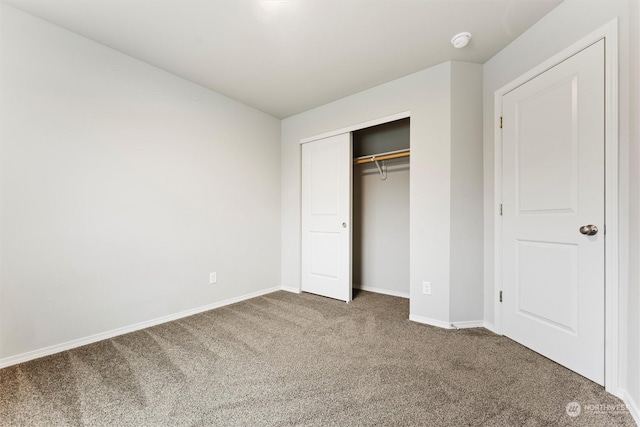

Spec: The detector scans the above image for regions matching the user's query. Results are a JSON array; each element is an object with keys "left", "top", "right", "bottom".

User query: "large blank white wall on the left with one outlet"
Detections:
[{"left": 0, "top": 4, "right": 280, "bottom": 363}]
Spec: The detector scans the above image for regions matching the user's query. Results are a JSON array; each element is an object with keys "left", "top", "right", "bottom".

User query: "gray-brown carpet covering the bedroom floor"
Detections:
[{"left": 0, "top": 292, "right": 635, "bottom": 426}]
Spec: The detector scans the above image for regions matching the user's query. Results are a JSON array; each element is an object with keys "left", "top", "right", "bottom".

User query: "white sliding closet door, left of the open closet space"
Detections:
[{"left": 302, "top": 133, "right": 352, "bottom": 302}]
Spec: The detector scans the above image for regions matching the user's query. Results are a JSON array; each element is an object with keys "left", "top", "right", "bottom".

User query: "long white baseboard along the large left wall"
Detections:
[{"left": 0, "top": 286, "right": 282, "bottom": 369}]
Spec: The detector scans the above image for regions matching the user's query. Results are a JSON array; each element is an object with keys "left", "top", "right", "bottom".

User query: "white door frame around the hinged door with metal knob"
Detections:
[{"left": 493, "top": 20, "right": 620, "bottom": 395}]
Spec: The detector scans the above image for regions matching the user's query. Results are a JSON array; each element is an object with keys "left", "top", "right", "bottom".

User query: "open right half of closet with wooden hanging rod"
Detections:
[{"left": 352, "top": 118, "right": 410, "bottom": 298}]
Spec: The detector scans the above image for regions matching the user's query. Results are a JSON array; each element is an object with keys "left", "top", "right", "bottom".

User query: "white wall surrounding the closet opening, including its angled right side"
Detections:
[{"left": 281, "top": 62, "right": 482, "bottom": 327}]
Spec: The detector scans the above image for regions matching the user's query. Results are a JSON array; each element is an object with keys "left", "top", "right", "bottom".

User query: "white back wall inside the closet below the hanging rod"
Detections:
[{"left": 352, "top": 157, "right": 410, "bottom": 298}]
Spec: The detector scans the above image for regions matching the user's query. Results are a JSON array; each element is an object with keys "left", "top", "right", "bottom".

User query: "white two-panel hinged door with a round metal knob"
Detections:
[{"left": 502, "top": 40, "right": 605, "bottom": 384}]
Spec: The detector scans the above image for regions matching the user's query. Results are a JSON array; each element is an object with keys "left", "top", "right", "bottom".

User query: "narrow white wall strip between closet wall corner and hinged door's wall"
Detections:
[{"left": 450, "top": 62, "right": 483, "bottom": 322}]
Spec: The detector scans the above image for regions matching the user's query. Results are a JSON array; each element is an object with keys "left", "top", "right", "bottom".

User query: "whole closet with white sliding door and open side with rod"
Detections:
[{"left": 301, "top": 117, "right": 410, "bottom": 302}]
